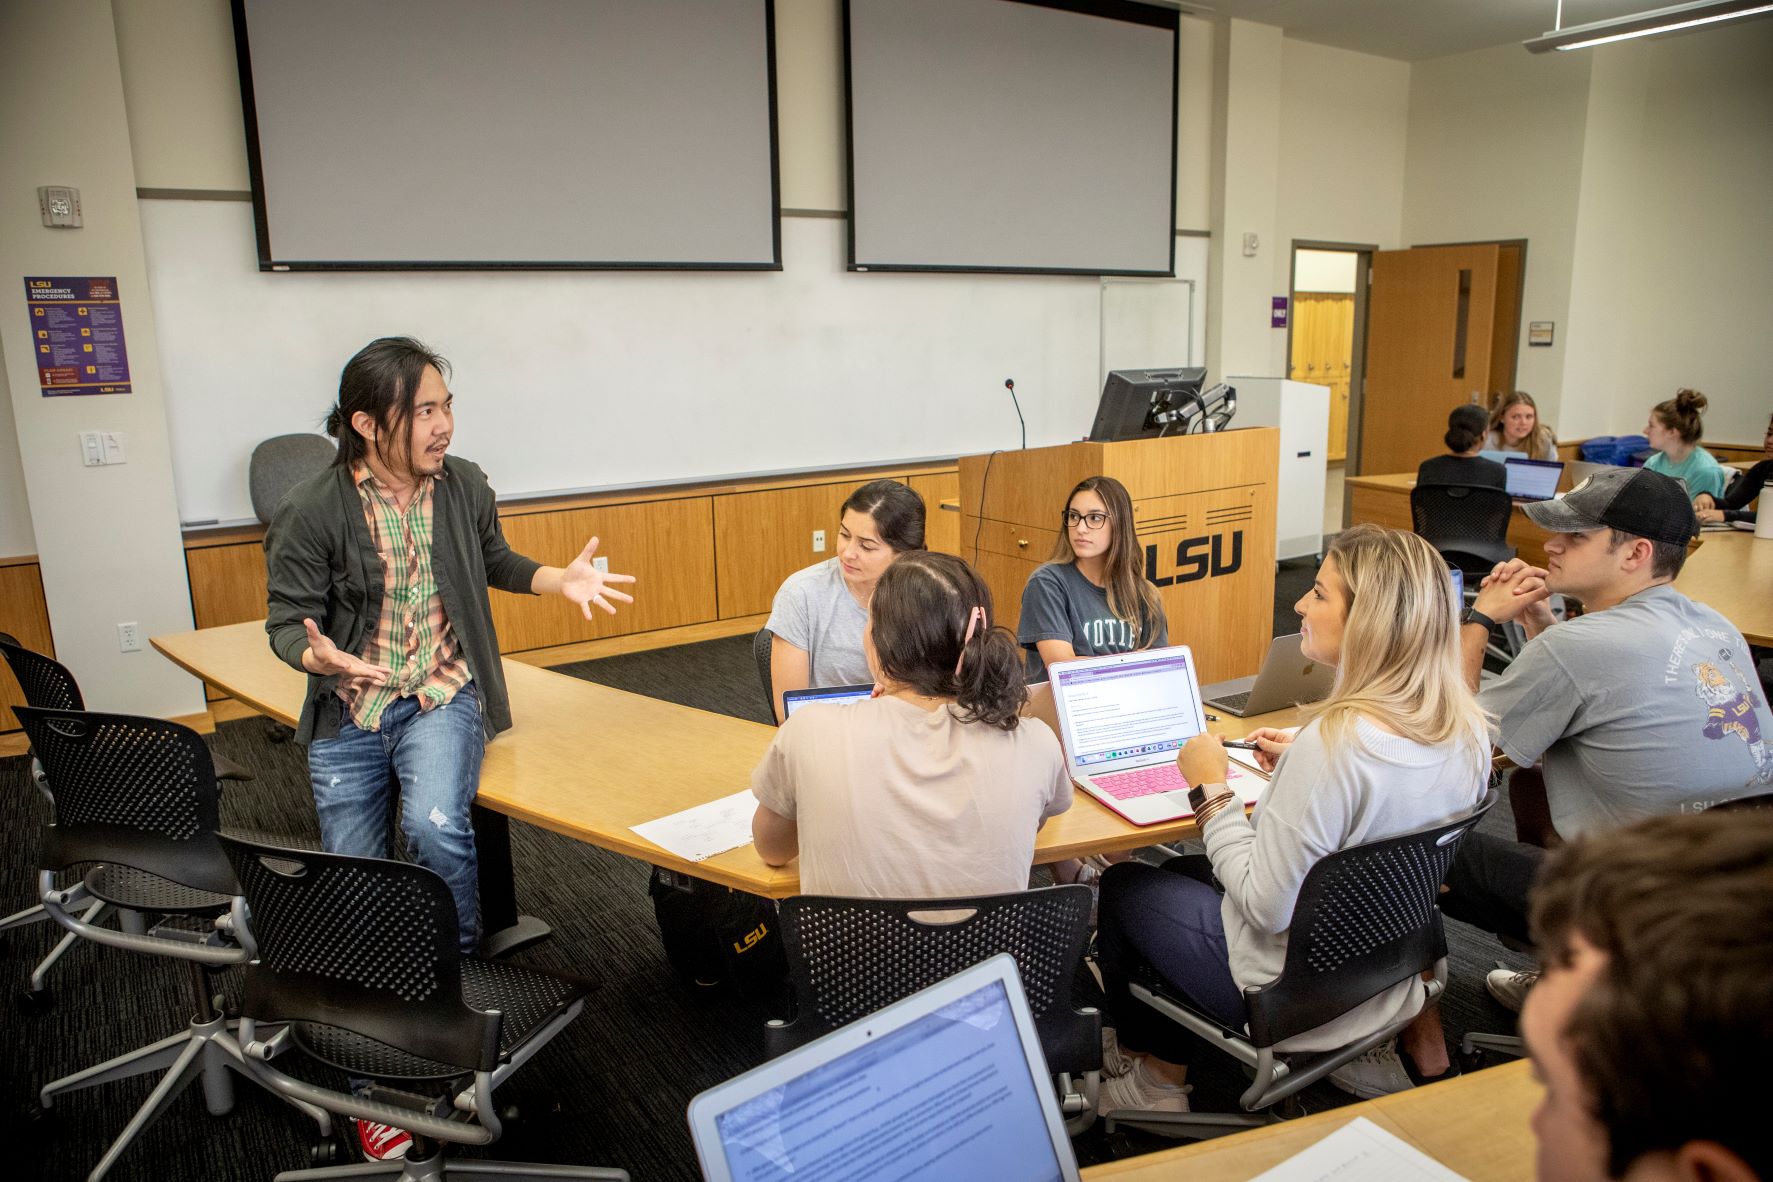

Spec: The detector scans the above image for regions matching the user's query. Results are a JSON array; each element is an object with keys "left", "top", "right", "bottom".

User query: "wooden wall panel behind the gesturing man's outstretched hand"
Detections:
[{"left": 491, "top": 496, "right": 715, "bottom": 652}]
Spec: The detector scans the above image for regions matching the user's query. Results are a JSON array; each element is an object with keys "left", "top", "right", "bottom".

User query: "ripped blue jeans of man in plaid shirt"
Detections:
[{"left": 309, "top": 682, "right": 486, "bottom": 952}]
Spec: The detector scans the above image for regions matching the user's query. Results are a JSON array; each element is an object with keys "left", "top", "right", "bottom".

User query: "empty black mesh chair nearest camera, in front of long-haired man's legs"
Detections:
[{"left": 222, "top": 836, "right": 628, "bottom": 1182}]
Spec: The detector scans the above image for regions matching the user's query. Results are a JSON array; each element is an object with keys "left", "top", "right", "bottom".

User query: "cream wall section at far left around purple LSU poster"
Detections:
[{"left": 0, "top": 0, "right": 204, "bottom": 716}]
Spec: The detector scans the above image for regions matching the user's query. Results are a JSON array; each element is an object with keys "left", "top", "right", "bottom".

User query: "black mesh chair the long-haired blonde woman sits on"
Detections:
[{"left": 1105, "top": 789, "right": 1496, "bottom": 1138}]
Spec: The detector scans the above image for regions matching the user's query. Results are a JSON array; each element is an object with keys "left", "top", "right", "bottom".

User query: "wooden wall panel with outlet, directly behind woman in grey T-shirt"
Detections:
[{"left": 715, "top": 480, "right": 851, "bottom": 618}]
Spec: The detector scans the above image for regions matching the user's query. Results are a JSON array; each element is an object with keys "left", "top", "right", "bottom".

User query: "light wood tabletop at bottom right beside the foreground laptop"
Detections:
[{"left": 1083, "top": 1063, "right": 1541, "bottom": 1182}]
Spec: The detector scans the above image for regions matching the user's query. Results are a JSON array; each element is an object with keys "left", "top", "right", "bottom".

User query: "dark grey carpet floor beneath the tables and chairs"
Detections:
[{"left": 0, "top": 562, "right": 1518, "bottom": 1182}]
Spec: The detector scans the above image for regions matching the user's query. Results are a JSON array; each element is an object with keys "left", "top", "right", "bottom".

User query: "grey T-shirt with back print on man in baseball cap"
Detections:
[{"left": 1477, "top": 585, "right": 1773, "bottom": 838}]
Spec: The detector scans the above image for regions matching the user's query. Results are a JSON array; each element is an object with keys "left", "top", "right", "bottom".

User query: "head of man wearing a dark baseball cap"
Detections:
[{"left": 1525, "top": 468, "right": 1699, "bottom": 608}]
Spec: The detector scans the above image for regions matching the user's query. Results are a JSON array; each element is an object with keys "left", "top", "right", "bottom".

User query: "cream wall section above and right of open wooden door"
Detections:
[{"left": 1402, "top": 44, "right": 1592, "bottom": 438}]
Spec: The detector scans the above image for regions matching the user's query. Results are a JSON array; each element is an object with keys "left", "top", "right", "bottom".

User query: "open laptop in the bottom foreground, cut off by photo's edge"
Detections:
[{"left": 690, "top": 953, "right": 1078, "bottom": 1182}]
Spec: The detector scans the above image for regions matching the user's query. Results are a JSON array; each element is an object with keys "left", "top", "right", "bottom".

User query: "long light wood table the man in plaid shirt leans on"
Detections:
[{"left": 152, "top": 620, "right": 1298, "bottom": 932}]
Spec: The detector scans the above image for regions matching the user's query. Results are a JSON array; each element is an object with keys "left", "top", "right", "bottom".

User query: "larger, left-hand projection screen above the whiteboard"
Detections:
[{"left": 232, "top": 0, "right": 780, "bottom": 271}]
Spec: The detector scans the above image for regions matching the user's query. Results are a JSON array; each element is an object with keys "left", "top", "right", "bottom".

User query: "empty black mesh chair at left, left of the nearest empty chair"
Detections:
[{"left": 18, "top": 707, "right": 332, "bottom": 1178}]
